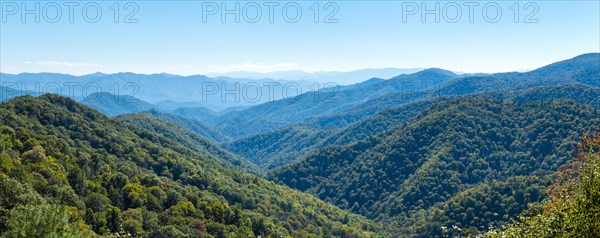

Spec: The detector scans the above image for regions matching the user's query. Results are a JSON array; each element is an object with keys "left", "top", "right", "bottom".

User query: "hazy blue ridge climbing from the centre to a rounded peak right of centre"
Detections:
[{"left": 215, "top": 69, "right": 458, "bottom": 138}]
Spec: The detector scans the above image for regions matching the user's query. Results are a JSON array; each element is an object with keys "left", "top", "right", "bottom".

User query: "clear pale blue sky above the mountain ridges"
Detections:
[{"left": 0, "top": 0, "right": 600, "bottom": 75}]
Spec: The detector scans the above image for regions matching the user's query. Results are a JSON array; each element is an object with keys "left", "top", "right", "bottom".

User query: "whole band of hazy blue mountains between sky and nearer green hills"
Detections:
[{"left": 1, "top": 53, "right": 600, "bottom": 141}]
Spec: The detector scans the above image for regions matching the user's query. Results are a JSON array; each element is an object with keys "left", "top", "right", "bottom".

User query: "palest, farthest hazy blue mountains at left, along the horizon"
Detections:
[{"left": 0, "top": 73, "right": 319, "bottom": 111}]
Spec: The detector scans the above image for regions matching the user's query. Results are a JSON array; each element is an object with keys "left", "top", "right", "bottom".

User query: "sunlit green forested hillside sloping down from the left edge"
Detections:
[{"left": 0, "top": 95, "right": 379, "bottom": 237}]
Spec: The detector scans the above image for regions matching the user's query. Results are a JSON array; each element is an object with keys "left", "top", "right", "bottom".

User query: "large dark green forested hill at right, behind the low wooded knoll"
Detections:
[{"left": 269, "top": 97, "right": 600, "bottom": 236}]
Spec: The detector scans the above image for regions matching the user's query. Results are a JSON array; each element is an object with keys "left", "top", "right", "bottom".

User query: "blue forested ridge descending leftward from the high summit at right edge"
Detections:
[{"left": 307, "top": 53, "right": 600, "bottom": 128}]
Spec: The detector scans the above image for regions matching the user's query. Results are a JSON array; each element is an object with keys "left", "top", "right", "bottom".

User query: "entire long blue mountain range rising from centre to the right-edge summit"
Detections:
[{"left": 212, "top": 53, "right": 600, "bottom": 137}]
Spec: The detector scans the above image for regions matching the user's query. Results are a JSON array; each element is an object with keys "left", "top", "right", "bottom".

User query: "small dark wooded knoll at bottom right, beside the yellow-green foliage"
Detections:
[{"left": 392, "top": 176, "right": 550, "bottom": 237}]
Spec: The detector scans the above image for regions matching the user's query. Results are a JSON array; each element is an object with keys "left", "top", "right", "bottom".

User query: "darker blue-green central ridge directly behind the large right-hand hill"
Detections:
[{"left": 223, "top": 100, "right": 432, "bottom": 170}]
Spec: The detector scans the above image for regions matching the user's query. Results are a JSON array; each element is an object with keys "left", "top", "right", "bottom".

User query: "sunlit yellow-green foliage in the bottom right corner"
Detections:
[{"left": 482, "top": 134, "right": 600, "bottom": 237}]
